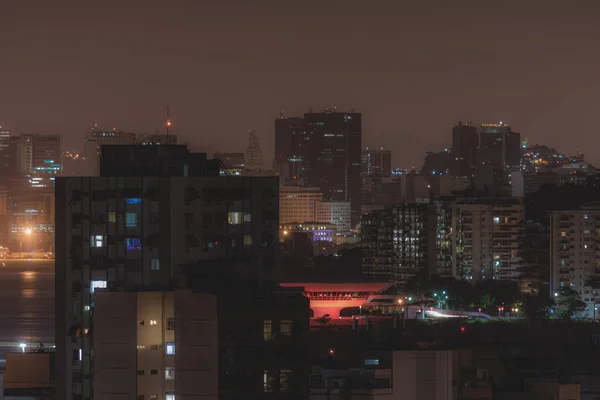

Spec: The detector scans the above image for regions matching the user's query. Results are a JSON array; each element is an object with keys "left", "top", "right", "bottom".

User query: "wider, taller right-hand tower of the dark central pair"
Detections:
[{"left": 304, "top": 109, "right": 362, "bottom": 226}]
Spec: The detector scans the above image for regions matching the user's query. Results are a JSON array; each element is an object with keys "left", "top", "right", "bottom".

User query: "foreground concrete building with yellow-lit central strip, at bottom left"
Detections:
[{"left": 96, "top": 288, "right": 219, "bottom": 400}]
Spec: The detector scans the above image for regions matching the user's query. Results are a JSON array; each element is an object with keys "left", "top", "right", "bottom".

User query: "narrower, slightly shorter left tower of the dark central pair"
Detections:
[{"left": 273, "top": 115, "right": 312, "bottom": 184}]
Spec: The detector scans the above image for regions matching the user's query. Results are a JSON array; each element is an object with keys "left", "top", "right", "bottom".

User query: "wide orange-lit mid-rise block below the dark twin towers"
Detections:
[{"left": 279, "top": 186, "right": 323, "bottom": 225}]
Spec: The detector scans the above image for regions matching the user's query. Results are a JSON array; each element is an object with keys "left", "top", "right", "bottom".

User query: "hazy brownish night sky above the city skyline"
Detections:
[{"left": 0, "top": 0, "right": 600, "bottom": 167}]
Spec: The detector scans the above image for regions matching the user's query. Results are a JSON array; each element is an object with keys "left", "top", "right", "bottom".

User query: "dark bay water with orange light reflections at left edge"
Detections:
[{"left": 0, "top": 260, "right": 54, "bottom": 358}]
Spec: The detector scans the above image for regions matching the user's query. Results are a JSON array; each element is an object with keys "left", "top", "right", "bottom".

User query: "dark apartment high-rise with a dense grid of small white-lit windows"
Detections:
[{"left": 392, "top": 203, "right": 437, "bottom": 282}]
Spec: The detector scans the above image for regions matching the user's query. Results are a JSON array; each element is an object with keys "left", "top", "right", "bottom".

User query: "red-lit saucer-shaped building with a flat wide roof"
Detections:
[{"left": 280, "top": 282, "right": 392, "bottom": 318}]
